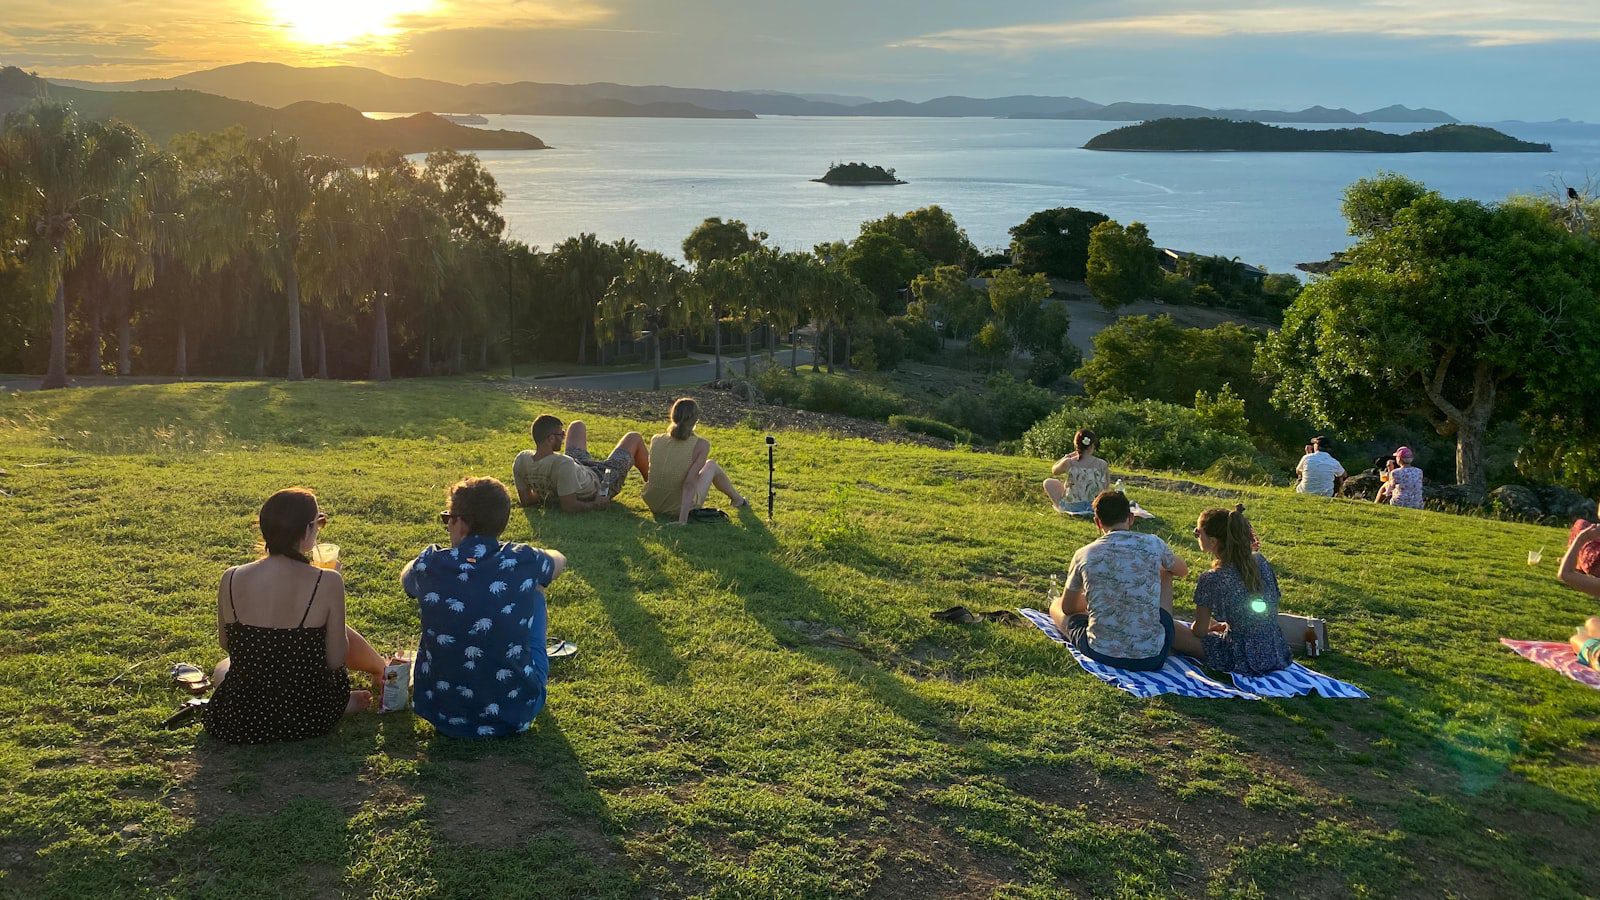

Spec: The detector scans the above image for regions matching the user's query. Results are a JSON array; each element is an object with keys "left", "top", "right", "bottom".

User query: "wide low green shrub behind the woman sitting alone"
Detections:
[{"left": 1022, "top": 400, "right": 1254, "bottom": 472}]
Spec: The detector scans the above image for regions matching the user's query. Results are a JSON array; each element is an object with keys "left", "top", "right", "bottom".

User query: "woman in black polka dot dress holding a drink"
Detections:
[{"left": 205, "top": 488, "right": 384, "bottom": 743}]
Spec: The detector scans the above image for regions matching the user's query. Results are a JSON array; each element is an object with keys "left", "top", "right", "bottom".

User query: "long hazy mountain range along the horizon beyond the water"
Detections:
[{"left": 40, "top": 62, "right": 1456, "bottom": 123}]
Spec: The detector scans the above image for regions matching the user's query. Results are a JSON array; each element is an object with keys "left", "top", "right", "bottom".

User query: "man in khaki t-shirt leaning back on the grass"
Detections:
[{"left": 510, "top": 415, "right": 650, "bottom": 512}]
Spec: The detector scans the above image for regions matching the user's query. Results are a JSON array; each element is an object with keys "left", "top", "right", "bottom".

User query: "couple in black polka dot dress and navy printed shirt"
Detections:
[{"left": 202, "top": 479, "right": 566, "bottom": 743}]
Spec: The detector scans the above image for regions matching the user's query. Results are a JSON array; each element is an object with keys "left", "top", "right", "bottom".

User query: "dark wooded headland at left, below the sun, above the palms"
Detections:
[{"left": 0, "top": 66, "right": 544, "bottom": 162}]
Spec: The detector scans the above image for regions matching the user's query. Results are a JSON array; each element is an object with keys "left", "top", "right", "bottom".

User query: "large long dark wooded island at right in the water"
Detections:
[{"left": 1083, "top": 119, "right": 1552, "bottom": 154}]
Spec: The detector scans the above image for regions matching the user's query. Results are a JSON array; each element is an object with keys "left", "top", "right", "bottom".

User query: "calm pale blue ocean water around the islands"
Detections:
[{"left": 412, "top": 115, "right": 1600, "bottom": 271}]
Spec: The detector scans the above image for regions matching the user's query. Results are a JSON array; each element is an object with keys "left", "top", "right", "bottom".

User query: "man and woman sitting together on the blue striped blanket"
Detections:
[{"left": 1050, "top": 490, "right": 1293, "bottom": 674}]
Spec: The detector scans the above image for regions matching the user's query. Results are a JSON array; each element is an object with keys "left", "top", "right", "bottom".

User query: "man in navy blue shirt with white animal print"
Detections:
[{"left": 400, "top": 479, "right": 566, "bottom": 738}]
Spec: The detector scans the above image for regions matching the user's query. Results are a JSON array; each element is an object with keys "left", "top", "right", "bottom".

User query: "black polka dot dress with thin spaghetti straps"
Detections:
[{"left": 205, "top": 572, "right": 350, "bottom": 743}]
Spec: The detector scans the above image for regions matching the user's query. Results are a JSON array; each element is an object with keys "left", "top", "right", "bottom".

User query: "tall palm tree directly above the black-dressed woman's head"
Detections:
[{"left": 237, "top": 136, "right": 342, "bottom": 381}]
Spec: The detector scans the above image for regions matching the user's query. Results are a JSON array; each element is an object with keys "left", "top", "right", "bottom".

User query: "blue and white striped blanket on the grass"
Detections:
[{"left": 1018, "top": 609, "right": 1366, "bottom": 700}]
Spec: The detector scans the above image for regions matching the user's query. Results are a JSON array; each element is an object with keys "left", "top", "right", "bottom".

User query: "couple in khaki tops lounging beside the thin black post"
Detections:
[{"left": 512, "top": 397, "right": 749, "bottom": 525}]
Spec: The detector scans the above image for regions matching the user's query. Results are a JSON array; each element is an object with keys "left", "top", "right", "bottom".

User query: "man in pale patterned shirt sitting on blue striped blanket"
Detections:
[{"left": 1050, "top": 490, "right": 1200, "bottom": 671}]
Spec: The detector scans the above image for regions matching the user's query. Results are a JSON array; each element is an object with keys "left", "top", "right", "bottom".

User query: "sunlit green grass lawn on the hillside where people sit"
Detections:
[{"left": 0, "top": 381, "right": 1600, "bottom": 900}]
